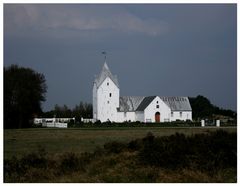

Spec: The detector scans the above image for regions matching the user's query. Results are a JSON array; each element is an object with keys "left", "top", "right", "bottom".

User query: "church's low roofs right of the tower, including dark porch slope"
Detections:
[{"left": 118, "top": 96, "right": 192, "bottom": 112}]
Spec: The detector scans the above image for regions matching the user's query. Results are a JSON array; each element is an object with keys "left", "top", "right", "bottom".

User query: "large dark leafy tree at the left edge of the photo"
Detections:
[{"left": 4, "top": 65, "right": 47, "bottom": 128}]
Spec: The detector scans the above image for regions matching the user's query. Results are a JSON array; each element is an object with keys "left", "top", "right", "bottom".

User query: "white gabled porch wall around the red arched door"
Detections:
[{"left": 144, "top": 96, "right": 171, "bottom": 122}]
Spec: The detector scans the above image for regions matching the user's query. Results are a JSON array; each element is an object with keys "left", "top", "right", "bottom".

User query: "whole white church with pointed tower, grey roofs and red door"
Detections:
[{"left": 93, "top": 61, "right": 192, "bottom": 122}]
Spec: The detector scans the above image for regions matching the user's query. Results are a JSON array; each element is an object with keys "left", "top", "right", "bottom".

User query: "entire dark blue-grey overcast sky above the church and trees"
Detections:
[{"left": 4, "top": 4, "right": 237, "bottom": 111}]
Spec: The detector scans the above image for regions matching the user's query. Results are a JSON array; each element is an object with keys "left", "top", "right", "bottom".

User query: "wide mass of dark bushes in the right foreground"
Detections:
[{"left": 138, "top": 130, "right": 237, "bottom": 173}]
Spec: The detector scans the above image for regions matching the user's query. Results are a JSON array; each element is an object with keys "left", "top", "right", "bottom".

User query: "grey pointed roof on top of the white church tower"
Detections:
[{"left": 94, "top": 62, "right": 119, "bottom": 88}]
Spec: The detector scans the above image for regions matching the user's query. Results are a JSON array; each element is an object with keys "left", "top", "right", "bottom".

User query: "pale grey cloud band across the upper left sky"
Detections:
[{"left": 4, "top": 4, "right": 167, "bottom": 36}]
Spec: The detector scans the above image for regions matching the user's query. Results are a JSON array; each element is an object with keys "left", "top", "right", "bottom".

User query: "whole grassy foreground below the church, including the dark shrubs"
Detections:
[{"left": 4, "top": 127, "right": 237, "bottom": 183}]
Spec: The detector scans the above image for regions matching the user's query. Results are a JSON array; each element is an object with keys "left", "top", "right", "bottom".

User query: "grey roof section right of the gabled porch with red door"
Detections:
[{"left": 160, "top": 97, "right": 192, "bottom": 111}]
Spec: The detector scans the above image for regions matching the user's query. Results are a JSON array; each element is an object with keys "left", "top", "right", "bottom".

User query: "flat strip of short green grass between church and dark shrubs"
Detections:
[{"left": 4, "top": 127, "right": 237, "bottom": 159}]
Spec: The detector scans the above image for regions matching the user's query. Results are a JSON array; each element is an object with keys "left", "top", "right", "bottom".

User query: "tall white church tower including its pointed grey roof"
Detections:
[{"left": 93, "top": 61, "right": 120, "bottom": 122}]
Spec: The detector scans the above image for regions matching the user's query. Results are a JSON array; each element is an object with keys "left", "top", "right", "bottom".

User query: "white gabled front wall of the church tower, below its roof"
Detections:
[{"left": 97, "top": 77, "right": 119, "bottom": 122}]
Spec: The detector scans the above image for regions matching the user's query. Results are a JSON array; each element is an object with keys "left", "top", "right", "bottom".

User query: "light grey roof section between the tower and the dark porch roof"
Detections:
[{"left": 118, "top": 96, "right": 144, "bottom": 112}]
